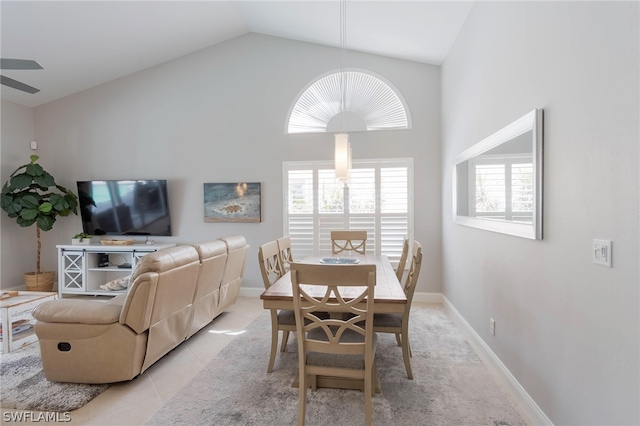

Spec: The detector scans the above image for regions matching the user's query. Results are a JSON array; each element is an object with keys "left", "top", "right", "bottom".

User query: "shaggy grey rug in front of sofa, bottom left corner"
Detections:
[{"left": 0, "top": 344, "right": 109, "bottom": 412}]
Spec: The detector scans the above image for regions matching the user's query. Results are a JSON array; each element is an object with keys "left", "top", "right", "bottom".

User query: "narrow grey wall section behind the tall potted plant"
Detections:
[{"left": 0, "top": 100, "right": 43, "bottom": 288}]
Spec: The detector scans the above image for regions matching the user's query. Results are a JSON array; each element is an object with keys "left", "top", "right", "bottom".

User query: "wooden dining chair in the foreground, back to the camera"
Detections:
[{"left": 291, "top": 263, "right": 377, "bottom": 425}]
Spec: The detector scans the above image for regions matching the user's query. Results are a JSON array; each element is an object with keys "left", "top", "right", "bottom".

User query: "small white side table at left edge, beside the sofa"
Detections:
[{"left": 0, "top": 291, "right": 58, "bottom": 353}]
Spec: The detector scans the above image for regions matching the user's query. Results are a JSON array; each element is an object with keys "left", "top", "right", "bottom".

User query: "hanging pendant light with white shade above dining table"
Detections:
[{"left": 334, "top": 0, "right": 351, "bottom": 185}]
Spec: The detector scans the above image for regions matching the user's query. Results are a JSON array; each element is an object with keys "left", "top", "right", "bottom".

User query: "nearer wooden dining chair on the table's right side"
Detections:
[{"left": 373, "top": 241, "right": 422, "bottom": 379}]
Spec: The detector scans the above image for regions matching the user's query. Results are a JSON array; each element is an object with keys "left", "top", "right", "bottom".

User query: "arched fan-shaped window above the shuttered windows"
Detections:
[{"left": 287, "top": 70, "right": 411, "bottom": 133}]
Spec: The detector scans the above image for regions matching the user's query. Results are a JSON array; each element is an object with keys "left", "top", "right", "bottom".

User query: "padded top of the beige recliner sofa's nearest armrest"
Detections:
[{"left": 32, "top": 299, "right": 122, "bottom": 324}]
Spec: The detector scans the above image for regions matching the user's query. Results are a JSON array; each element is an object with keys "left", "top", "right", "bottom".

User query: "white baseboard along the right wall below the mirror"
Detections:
[{"left": 441, "top": 295, "right": 553, "bottom": 426}]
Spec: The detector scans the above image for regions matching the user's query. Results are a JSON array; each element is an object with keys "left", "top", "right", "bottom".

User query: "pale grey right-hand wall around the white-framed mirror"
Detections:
[{"left": 442, "top": 2, "right": 640, "bottom": 425}]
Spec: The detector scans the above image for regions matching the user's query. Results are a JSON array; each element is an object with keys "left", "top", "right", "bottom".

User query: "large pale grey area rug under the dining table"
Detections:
[{"left": 145, "top": 306, "right": 527, "bottom": 426}]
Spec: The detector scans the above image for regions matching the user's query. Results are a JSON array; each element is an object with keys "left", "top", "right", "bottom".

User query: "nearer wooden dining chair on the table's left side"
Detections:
[{"left": 258, "top": 241, "right": 296, "bottom": 373}]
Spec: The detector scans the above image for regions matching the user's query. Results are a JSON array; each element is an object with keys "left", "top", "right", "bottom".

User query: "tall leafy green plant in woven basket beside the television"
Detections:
[{"left": 0, "top": 155, "right": 78, "bottom": 291}]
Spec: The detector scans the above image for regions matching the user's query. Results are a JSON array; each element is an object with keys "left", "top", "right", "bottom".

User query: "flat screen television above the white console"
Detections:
[{"left": 78, "top": 179, "right": 172, "bottom": 236}]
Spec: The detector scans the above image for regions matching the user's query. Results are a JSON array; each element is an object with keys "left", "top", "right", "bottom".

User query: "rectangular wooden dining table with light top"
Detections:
[{"left": 260, "top": 254, "right": 407, "bottom": 391}]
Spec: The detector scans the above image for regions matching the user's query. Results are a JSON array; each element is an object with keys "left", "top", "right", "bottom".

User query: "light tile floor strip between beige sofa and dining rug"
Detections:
[{"left": 0, "top": 297, "right": 267, "bottom": 426}]
